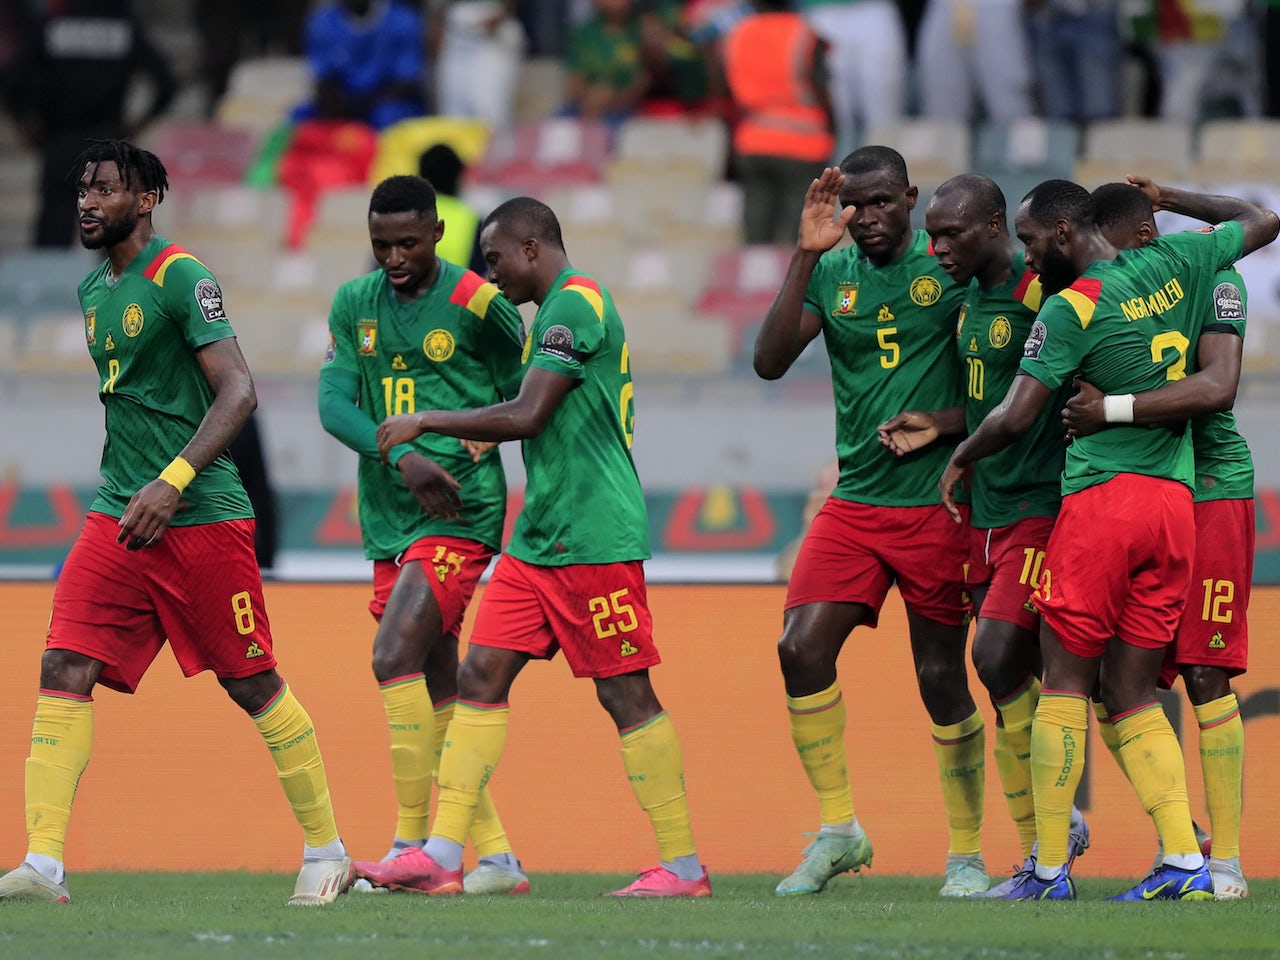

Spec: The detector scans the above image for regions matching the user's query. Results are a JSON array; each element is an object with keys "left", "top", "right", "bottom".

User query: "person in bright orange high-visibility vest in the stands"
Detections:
[{"left": 722, "top": 0, "right": 836, "bottom": 243}]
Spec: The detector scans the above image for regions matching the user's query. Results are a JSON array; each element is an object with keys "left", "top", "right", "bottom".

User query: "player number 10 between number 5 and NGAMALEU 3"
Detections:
[{"left": 879, "top": 173, "right": 1089, "bottom": 897}]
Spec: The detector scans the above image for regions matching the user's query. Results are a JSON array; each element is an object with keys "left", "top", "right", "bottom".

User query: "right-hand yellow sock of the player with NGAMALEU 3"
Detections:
[{"left": 1112, "top": 703, "right": 1199, "bottom": 856}]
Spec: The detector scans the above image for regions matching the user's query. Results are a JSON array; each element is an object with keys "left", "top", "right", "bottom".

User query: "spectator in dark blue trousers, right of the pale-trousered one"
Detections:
[{"left": 1028, "top": 0, "right": 1124, "bottom": 123}]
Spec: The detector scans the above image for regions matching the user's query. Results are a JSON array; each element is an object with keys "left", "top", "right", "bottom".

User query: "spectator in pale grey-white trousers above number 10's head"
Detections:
[{"left": 915, "top": 0, "right": 1032, "bottom": 123}]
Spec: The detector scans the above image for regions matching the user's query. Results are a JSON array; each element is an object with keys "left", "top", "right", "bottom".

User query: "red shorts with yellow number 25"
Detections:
[{"left": 471, "top": 553, "right": 662, "bottom": 678}]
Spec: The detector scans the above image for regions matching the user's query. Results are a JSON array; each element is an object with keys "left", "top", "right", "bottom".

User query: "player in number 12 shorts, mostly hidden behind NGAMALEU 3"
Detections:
[{"left": 1066, "top": 178, "right": 1254, "bottom": 900}]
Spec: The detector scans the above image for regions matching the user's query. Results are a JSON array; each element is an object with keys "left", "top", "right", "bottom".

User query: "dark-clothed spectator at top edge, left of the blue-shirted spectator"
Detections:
[{"left": 196, "top": 0, "right": 307, "bottom": 116}]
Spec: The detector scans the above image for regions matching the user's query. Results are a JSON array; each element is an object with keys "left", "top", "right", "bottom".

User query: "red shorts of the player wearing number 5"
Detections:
[{"left": 783, "top": 497, "right": 969, "bottom": 627}]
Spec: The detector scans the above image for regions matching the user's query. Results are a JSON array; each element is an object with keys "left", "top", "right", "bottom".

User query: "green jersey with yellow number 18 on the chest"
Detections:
[{"left": 320, "top": 260, "right": 522, "bottom": 559}]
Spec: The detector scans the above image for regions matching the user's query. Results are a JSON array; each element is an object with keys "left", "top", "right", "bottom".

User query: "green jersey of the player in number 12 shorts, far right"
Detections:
[{"left": 1192, "top": 268, "right": 1253, "bottom": 502}]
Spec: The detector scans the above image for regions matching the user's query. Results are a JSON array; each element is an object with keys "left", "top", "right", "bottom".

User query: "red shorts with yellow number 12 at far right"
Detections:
[{"left": 1160, "top": 500, "right": 1256, "bottom": 687}]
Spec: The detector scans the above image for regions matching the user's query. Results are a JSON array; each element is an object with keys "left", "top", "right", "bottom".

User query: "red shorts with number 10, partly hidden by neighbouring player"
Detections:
[{"left": 965, "top": 517, "right": 1053, "bottom": 632}]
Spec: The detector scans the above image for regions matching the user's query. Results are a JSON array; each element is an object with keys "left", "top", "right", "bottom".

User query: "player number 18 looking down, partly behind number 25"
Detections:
[{"left": 320, "top": 177, "right": 529, "bottom": 893}]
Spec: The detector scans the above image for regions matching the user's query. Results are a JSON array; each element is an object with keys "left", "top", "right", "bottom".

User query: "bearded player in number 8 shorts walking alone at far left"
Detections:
[{"left": 0, "top": 140, "right": 352, "bottom": 905}]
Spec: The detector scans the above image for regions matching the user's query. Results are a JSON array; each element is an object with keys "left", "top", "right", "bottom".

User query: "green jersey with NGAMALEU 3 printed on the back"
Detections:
[{"left": 1021, "top": 221, "right": 1244, "bottom": 494}]
